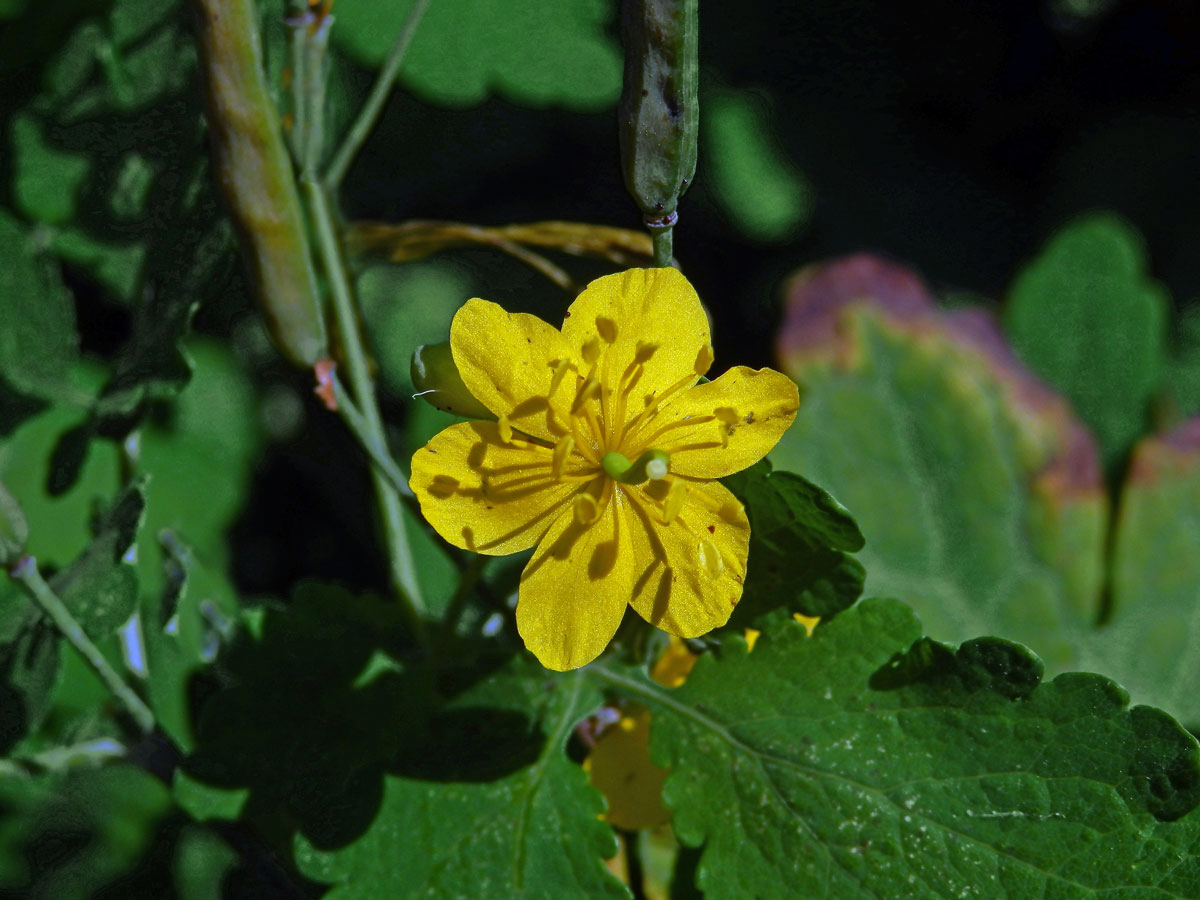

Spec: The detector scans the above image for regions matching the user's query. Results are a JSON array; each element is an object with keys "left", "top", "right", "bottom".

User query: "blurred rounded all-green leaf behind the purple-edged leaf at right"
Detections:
[{"left": 1004, "top": 214, "right": 1169, "bottom": 467}]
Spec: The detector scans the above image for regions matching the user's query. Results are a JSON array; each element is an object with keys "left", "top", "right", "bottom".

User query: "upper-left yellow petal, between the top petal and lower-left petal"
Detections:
[{"left": 450, "top": 300, "right": 574, "bottom": 439}]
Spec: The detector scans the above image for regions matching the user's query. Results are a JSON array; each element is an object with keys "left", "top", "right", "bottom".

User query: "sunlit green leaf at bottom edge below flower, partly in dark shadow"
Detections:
[{"left": 296, "top": 660, "right": 629, "bottom": 900}]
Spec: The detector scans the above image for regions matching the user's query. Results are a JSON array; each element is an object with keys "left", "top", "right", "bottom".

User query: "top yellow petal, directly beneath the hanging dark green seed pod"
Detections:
[{"left": 563, "top": 269, "right": 710, "bottom": 408}]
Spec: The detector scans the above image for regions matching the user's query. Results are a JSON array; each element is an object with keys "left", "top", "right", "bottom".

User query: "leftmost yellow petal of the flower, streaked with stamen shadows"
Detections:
[{"left": 408, "top": 422, "right": 581, "bottom": 556}]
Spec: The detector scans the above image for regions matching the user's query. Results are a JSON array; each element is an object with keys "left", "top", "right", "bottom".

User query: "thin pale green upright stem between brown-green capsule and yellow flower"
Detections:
[{"left": 300, "top": 179, "right": 425, "bottom": 643}]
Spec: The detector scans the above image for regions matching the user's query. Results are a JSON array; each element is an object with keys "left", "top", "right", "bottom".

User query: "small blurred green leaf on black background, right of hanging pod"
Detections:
[{"left": 701, "top": 89, "right": 815, "bottom": 241}]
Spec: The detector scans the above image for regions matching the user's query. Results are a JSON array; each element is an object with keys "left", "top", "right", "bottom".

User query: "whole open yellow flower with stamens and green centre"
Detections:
[{"left": 410, "top": 269, "right": 799, "bottom": 671}]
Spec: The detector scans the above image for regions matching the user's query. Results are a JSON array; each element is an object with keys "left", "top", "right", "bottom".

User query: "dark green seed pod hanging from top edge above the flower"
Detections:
[{"left": 617, "top": 0, "right": 700, "bottom": 227}]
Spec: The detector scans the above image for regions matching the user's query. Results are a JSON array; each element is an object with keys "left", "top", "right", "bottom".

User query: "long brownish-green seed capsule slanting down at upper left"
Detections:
[{"left": 192, "top": 0, "right": 326, "bottom": 366}]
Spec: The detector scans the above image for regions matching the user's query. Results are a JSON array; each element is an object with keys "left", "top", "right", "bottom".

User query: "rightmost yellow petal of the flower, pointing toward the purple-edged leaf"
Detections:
[{"left": 629, "top": 366, "right": 800, "bottom": 478}]
